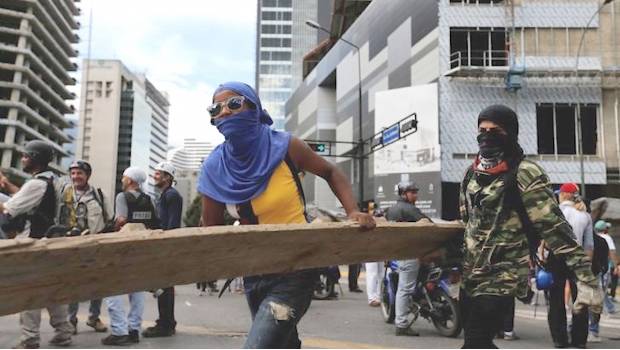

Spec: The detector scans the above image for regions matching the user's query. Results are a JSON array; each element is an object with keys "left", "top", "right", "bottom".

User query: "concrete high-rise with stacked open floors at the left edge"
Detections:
[{"left": 0, "top": 0, "right": 80, "bottom": 177}]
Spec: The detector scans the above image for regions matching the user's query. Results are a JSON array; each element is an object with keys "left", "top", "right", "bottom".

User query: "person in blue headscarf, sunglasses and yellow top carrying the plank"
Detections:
[{"left": 198, "top": 82, "right": 375, "bottom": 348}]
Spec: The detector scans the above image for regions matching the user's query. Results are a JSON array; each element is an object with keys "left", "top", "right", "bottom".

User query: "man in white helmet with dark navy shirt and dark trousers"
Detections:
[{"left": 142, "top": 162, "right": 183, "bottom": 338}]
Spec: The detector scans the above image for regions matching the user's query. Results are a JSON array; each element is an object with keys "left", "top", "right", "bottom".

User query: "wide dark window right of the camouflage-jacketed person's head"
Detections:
[{"left": 536, "top": 103, "right": 598, "bottom": 155}]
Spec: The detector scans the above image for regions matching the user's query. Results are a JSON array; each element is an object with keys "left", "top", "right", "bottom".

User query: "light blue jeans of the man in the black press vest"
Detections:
[{"left": 105, "top": 292, "right": 145, "bottom": 335}]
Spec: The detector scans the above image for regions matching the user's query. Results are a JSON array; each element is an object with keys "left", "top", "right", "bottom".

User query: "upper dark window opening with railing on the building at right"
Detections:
[{"left": 450, "top": 27, "right": 508, "bottom": 68}]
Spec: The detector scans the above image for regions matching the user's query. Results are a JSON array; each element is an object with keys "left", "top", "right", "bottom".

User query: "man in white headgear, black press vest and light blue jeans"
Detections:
[{"left": 101, "top": 167, "right": 159, "bottom": 346}]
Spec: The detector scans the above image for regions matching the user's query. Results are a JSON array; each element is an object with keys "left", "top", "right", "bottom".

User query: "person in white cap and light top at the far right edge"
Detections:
[{"left": 588, "top": 220, "right": 619, "bottom": 343}]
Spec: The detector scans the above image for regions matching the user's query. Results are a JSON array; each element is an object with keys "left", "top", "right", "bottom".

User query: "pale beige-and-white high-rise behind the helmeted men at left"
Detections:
[{"left": 76, "top": 60, "right": 169, "bottom": 204}]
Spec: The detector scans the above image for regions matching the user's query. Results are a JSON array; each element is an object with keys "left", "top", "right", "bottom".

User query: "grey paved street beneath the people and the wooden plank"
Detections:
[{"left": 0, "top": 269, "right": 620, "bottom": 349}]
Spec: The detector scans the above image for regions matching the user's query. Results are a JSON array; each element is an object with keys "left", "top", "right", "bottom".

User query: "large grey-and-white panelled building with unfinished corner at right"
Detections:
[{"left": 286, "top": 0, "right": 620, "bottom": 219}]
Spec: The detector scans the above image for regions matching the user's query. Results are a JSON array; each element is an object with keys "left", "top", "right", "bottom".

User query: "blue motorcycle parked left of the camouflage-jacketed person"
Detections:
[{"left": 381, "top": 261, "right": 463, "bottom": 338}]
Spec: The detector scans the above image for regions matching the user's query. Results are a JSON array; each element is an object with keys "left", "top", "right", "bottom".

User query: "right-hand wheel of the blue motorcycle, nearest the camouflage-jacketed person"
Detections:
[{"left": 431, "top": 288, "right": 463, "bottom": 338}]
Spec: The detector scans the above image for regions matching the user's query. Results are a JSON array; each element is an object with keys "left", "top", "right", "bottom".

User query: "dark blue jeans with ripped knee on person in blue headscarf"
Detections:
[{"left": 243, "top": 270, "right": 316, "bottom": 349}]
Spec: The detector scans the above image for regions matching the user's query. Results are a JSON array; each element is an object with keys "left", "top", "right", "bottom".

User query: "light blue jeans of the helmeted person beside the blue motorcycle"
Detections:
[{"left": 394, "top": 259, "right": 420, "bottom": 328}]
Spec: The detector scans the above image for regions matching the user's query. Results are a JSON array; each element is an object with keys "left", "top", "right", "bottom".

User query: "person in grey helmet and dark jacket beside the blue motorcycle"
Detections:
[{"left": 385, "top": 181, "right": 430, "bottom": 336}]
